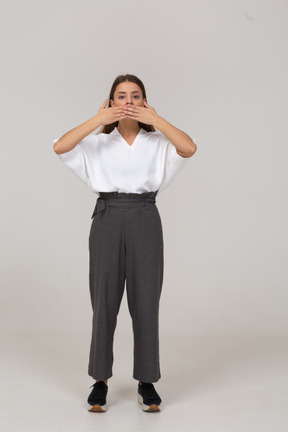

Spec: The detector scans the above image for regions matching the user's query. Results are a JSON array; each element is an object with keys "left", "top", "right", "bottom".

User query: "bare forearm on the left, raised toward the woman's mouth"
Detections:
[{"left": 53, "top": 115, "right": 101, "bottom": 154}]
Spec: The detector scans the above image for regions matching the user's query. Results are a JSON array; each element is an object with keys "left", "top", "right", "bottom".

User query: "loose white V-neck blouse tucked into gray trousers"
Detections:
[{"left": 53, "top": 127, "right": 195, "bottom": 194}]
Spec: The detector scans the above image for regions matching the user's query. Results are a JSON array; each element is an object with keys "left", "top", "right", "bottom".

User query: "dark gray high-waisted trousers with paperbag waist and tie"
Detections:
[{"left": 88, "top": 191, "right": 163, "bottom": 382}]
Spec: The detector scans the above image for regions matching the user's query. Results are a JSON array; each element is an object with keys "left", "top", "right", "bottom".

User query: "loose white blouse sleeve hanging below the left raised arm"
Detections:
[{"left": 53, "top": 137, "right": 89, "bottom": 185}]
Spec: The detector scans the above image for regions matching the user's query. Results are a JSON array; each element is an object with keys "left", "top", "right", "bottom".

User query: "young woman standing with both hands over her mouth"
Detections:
[{"left": 53, "top": 75, "right": 197, "bottom": 412}]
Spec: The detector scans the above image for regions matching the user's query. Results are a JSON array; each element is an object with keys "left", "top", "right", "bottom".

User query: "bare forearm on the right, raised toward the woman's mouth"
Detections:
[{"left": 153, "top": 116, "right": 197, "bottom": 157}]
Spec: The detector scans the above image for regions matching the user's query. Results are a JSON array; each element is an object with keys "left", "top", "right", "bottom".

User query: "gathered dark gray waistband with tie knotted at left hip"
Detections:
[{"left": 91, "top": 190, "right": 158, "bottom": 219}]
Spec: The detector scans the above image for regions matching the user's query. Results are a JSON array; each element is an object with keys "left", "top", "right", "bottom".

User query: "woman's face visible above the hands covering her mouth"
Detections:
[{"left": 111, "top": 81, "right": 146, "bottom": 106}]
